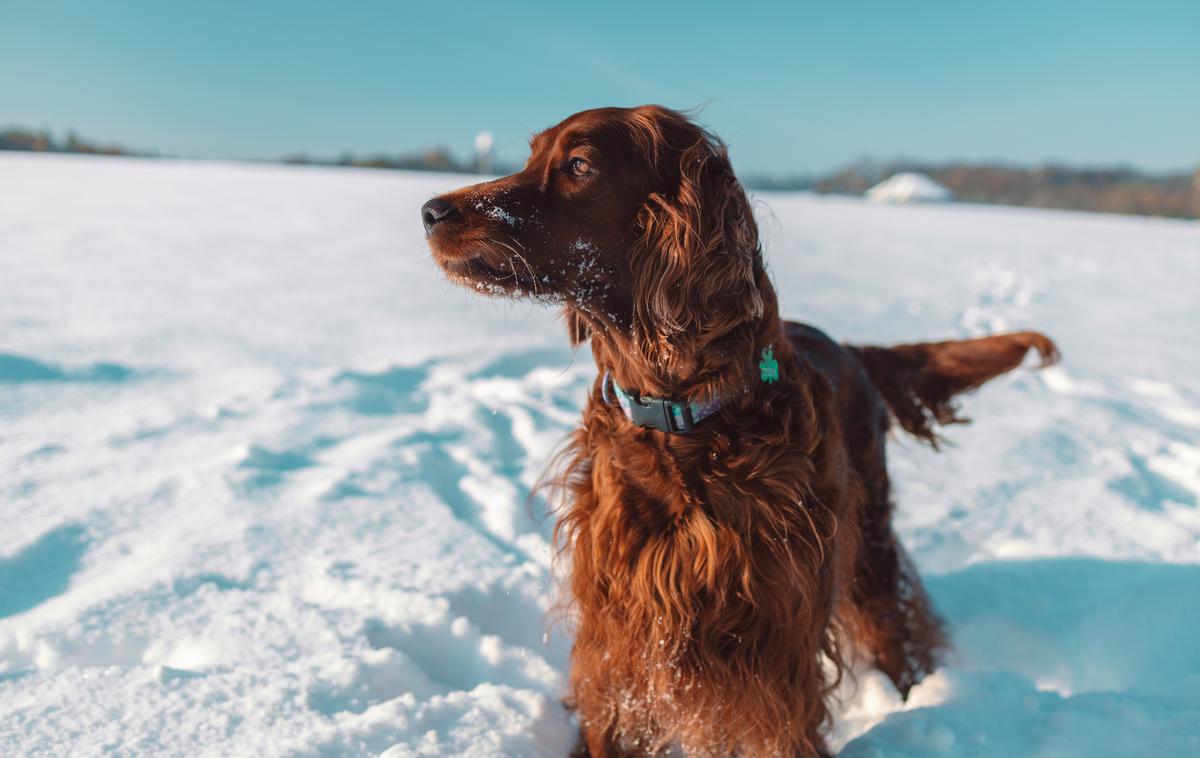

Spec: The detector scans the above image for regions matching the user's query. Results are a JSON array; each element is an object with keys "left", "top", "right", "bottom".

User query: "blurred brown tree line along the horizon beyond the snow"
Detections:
[{"left": 0, "top": 127, "right": 1200, "bottom": 218}]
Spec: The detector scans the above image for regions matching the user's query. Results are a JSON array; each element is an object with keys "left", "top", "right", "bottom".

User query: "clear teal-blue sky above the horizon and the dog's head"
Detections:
[{"left": 0, "top": 0, "right": 1200, "bottom": 174}]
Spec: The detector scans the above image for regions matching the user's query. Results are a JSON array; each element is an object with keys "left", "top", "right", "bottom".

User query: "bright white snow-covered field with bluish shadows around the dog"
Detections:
[{"left": 0, "top": 155, "right": 1200, "bottom": 758}]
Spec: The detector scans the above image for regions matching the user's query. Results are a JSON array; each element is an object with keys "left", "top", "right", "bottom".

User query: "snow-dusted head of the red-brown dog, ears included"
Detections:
[{"left": 421, "top": 106, "right": 763, "bottom": 383}]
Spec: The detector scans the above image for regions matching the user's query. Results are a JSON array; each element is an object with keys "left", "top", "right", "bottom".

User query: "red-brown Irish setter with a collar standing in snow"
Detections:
[{"left": 421, "top": 106, "right": 1056, "bottom": 757}]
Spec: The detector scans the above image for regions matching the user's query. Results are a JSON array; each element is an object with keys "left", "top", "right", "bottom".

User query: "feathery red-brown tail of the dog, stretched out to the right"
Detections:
[{"left": 848, "top": 332, "right": 1058, "bottom": 447}]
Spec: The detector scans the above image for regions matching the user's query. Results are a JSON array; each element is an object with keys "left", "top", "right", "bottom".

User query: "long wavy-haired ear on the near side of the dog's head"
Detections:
[{"left": 632, "top": 124, "right": 763, "bottom": 374}]
